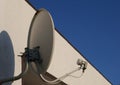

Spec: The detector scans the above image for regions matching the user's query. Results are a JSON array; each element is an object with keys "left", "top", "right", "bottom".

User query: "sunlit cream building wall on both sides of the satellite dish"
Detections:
[{"left": 0, "top": 0, "right": 111, "bottom": 85}]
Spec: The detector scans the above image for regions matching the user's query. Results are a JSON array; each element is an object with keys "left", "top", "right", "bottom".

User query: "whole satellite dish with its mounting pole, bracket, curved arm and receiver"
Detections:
[{"left": 0, "top": 8, "right": 87, "bottom": 84}]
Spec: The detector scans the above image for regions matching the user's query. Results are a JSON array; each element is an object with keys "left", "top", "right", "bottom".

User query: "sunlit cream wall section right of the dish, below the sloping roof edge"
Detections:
[{"left": 48, "top": 31, "right": 111, "bottom": 85}]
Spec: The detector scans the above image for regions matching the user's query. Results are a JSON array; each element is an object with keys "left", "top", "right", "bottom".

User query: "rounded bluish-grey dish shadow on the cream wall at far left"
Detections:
[{"left": 0, "top": 31, "right": 15, "bottom": 85}]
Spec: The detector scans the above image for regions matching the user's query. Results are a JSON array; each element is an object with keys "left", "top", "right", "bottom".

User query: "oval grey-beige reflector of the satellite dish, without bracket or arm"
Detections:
[{"left": 28, "top": 8, "right": 54, "bottom": 74}]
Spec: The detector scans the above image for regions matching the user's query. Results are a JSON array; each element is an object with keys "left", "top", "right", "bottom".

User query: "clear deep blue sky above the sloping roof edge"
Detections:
[{"left": 28, "top": 0, "right": 120, "bottom": 85}]
